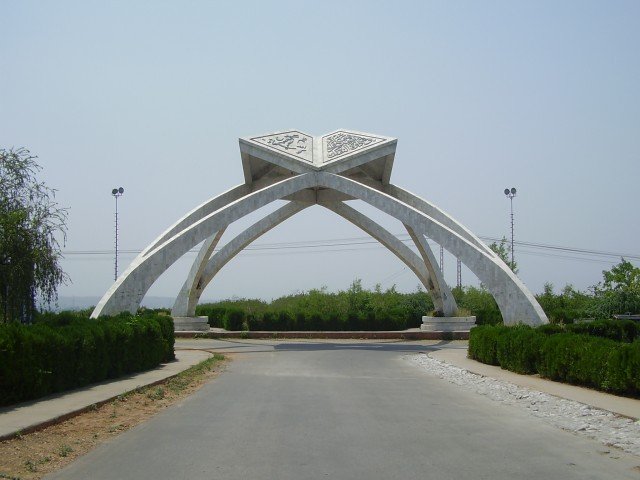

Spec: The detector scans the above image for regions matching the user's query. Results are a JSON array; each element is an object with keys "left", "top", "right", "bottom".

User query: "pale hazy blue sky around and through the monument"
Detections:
[{"left": 0, "top": 0, "right": 640, "bottom": 304}]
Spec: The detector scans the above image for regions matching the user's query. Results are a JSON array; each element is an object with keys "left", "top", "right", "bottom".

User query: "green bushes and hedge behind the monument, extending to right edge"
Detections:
[{"left": 196, "top": 259, "right": 640, "bottom": 330}]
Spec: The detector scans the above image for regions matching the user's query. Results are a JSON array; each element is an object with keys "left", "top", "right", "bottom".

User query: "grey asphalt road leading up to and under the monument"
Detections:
[{"left": 47, "top": 340, "right": 640, "bottom": 480}]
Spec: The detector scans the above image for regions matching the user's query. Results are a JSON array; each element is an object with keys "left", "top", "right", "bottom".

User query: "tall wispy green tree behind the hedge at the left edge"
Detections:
[{"left": 0, "top": 148, "right": 67, "bottom": 322}]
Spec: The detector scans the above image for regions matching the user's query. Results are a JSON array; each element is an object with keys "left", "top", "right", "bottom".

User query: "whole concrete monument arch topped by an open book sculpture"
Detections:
[{"left": 92, "top": 130, "right": 548, "bottom": 326}]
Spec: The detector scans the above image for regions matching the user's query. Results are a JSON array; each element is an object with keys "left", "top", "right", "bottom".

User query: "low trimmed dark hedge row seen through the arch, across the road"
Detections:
[{"left": 199, "top": 306, "right": 422, "bottom": 332}]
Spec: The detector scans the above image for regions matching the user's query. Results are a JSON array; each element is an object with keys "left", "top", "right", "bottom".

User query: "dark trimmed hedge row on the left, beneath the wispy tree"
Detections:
[{"left": 0, "top": 313, "right": 174, "bottom": 405}]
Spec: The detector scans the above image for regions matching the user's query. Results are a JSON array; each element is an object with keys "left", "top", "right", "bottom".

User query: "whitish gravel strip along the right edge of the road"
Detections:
[{"left": 405, "top": 354, "right": 640, "bottom": 455}]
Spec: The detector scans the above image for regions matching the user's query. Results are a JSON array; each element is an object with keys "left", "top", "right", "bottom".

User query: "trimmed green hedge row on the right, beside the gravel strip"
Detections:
[{"left": 469, "top": 325, "right": 640, "bottom": 396}]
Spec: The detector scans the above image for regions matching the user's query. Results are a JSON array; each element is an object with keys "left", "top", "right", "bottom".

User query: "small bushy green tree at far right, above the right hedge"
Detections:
[{"left": 593, "top": 258, "right": 640, "bottom": 318}]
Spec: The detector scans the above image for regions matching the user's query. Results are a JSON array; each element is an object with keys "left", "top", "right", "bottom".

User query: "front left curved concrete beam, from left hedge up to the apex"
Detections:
[{"left": 91, "top": 173, "right": 317, "bottom": 318}]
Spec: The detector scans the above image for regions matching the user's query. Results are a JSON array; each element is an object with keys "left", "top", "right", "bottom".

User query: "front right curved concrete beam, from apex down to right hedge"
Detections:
[{"left": 317, "top": 172, "right": 548, "bottom": 325}]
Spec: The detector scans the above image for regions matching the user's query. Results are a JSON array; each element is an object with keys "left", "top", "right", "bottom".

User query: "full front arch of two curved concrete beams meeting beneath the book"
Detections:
[{"left": 92, "top": 171, "right": 548, "bottom": 325}]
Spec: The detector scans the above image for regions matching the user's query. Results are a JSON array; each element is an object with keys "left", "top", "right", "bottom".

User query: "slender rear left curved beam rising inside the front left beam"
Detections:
[{"left": 171, "top": 202, "right": 311, "bottom": 317}]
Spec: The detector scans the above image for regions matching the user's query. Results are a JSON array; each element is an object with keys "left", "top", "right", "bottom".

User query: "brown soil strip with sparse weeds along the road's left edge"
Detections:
[{"left": 0, "top": 355, "right": 226, "bottom": 480}]
